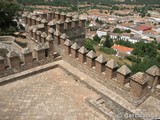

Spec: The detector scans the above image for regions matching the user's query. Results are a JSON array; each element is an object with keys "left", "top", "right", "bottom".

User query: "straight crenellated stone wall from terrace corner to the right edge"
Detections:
[{"left": 52, "top": 40, "right": 160, "bottom": 101}]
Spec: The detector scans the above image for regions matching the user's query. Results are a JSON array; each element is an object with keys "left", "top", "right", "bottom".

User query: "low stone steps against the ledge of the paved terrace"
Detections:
[{"left": 86, "top": 97, "right": 141, "bottom": 120}]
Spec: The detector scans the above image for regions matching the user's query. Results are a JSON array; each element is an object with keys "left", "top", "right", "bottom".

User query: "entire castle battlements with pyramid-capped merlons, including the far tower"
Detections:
[{"left": 0, "top": 12, "right": 160, "bottom": 108}]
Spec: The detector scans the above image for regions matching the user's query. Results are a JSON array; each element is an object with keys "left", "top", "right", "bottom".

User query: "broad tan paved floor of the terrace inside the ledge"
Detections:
[{"left": 0, "top": 68, "right": 105, "bottom": 120}]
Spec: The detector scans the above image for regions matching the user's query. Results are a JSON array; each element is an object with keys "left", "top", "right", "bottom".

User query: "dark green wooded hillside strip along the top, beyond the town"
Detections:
[{"left": 17, "top": 0, "right": 160, "bottom": 6}]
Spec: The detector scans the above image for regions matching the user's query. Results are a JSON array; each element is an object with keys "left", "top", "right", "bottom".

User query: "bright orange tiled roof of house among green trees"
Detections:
[{"left": 112, "top": 45, "right": 133, "bottom": 52}]
